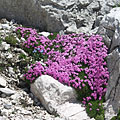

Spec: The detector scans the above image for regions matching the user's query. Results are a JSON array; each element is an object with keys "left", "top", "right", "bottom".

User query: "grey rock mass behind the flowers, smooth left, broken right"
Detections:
[{"left": 0, "top": 0, "right": 117, "bottom": 33}]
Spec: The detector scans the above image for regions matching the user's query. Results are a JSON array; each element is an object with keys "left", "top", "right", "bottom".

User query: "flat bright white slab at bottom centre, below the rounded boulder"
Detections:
[{"left": 57, "top": 102, "right": 90, "bottom": 120}]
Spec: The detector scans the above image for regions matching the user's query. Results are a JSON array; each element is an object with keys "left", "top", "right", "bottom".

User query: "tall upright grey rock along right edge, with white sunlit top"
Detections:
[{"left": 98, "top": 7, "right": 120, "bottom": 120}]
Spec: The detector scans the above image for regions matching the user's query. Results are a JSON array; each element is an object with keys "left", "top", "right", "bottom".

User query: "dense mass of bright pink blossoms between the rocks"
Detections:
[{"left": 17, "top": 27, "right": 109, "bottom": 103}]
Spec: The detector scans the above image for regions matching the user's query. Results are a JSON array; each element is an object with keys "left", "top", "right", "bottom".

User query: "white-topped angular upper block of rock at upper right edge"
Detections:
[{"left": 97, "top": 8, "right": 120, "bottom": 52}]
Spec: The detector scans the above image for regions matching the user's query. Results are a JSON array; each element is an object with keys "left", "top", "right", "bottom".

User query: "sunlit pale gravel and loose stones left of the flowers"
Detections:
[{"left": 0, "top": 19, "right": 63, "bottom": 120}]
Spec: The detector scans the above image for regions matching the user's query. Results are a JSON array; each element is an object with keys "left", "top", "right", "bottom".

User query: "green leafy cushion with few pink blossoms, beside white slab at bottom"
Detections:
[{"left": 86, "top": 100, "right": 104, "bottom": 120}]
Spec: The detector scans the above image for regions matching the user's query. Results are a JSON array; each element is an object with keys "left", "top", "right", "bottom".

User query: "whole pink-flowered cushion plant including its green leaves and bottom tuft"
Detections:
[{"left": 18, "top": 27, "right": 109, "bottom": 120}]
